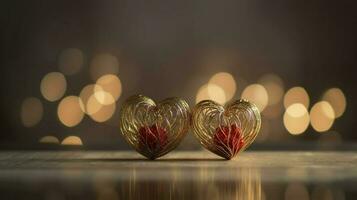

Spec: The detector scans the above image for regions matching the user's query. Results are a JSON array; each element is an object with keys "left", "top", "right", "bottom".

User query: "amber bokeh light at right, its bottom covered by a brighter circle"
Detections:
[{"left": 284, "top": 87, "right": 310, "bottom": 108}]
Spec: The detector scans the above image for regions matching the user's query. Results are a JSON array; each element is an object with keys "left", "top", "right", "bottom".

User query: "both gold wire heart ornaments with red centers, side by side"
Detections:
[{"left": 120, "top": 95, "right": 261, "bottom": 160}]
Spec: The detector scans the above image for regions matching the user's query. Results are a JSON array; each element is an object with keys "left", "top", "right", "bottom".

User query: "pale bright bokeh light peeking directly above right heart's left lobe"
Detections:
[{"left": 196, "top": 83, "right": 226, "bottom": 105}]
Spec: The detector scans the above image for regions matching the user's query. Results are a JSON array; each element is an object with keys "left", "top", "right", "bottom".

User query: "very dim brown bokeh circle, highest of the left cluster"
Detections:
[{"left": 58, "top": 48, "right": 84, "bottom": 75}]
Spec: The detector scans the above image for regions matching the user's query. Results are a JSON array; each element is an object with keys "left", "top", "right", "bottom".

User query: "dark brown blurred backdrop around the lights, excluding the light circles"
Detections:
[{"left": 0, "top": 0, "right": 357, "bottom": 149}]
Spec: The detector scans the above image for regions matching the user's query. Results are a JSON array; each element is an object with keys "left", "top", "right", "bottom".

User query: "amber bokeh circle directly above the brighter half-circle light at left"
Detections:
[{"left": 57, "top": 96, "right": 84, "bottom": 127}]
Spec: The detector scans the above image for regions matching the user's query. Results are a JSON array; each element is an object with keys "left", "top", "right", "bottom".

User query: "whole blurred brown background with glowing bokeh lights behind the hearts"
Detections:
[{"left": 0, "top": 0, "right": 357, "bottom": 150}]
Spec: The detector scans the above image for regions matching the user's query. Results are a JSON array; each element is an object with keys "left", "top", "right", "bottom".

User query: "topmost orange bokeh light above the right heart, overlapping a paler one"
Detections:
[{"left": 209, "top": 72, "right": 237, "bottom": 101}]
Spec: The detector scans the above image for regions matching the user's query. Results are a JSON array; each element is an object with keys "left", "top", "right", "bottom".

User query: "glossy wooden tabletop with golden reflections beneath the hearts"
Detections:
[{"left": 0, "top": 151, "right": 357, "bottom": 199}]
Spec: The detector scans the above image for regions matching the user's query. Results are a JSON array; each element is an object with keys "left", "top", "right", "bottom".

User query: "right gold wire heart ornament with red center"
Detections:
[{"left": 192, "top": 99, "right": 261, "bottom": 160}]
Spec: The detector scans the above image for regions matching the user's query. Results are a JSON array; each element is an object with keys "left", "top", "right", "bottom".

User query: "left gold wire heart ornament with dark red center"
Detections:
[{"left": 120, "top": 95, "right": 191, "bottom": 160}]
